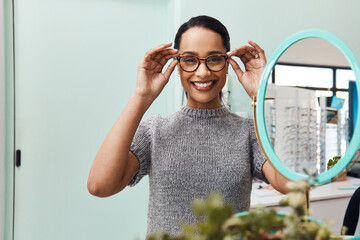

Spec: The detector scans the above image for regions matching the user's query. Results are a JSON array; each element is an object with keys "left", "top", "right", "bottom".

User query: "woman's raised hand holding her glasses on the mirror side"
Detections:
[{"left": 227, "top": 41, "right": 266, "bottom": 98}]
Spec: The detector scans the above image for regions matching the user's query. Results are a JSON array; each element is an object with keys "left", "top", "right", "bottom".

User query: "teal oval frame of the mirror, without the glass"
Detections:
[{"left": 256, "top": 29, "right": 360, "bottom": 184}]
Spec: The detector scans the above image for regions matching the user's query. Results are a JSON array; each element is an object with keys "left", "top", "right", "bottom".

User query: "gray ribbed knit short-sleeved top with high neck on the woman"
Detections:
[{"left": 129, "top": 107, "right": 266, "bottom": 234}]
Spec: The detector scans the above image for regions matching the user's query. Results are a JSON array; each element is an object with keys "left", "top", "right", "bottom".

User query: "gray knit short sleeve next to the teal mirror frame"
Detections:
[{"left": 248, "top": 119, "right": 269, "bottom": 183}]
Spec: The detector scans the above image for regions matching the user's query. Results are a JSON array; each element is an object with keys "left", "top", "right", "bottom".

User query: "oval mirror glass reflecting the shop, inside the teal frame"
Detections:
[{"left": 264, "top": 38, "right": 357, "bottom": 177}]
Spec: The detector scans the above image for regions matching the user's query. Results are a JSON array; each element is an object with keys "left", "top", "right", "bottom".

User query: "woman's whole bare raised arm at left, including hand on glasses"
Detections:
[{"left": 87, "top": 43, "right": 178, "bottom": 197}]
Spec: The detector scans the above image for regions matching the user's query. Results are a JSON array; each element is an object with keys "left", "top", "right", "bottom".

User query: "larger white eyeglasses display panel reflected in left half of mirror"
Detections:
[{"left": 265, "top": 85, "right": 324, "bottom": 172}]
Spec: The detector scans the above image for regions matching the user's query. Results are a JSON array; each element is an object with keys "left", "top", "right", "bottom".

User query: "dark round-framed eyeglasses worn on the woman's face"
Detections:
[{"left": 176, "top": 54, "right": 228, "bottom": 72}]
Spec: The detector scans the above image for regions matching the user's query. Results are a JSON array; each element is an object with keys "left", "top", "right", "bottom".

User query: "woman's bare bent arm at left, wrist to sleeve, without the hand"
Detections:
[{"left": 87, "top": 94, "right": 149, "bottom": 197}]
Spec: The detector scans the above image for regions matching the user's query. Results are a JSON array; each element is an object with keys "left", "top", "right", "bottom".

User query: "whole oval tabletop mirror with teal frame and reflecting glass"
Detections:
[{"left": 256, "top": 30, "right": 360, "bottom": 184}]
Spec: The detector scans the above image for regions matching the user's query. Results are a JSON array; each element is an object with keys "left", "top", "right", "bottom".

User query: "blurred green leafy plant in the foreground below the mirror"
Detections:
[{"left": 147, "top": 172, "right": 342, "bottom": 240}]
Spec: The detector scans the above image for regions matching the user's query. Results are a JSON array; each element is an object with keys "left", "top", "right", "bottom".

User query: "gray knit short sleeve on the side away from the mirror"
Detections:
[{"left": 128, "top": 118, "right": 152, "bottom": 187}]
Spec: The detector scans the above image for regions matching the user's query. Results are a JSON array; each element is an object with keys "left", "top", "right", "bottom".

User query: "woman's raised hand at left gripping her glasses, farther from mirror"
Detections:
[{"left": 135, "top": 43, "right": 179, "bottom": 102}]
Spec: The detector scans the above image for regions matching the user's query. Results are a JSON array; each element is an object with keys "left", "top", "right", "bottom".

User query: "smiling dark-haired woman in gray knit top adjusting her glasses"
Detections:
[{"left": 88, "top": 16, "right": 286, "bottom": 234}]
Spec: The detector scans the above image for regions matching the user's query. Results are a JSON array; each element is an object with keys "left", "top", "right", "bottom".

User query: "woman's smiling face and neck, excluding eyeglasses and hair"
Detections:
[{"left": 177, "top": 27, "right": 228, "bottom": 108}]
